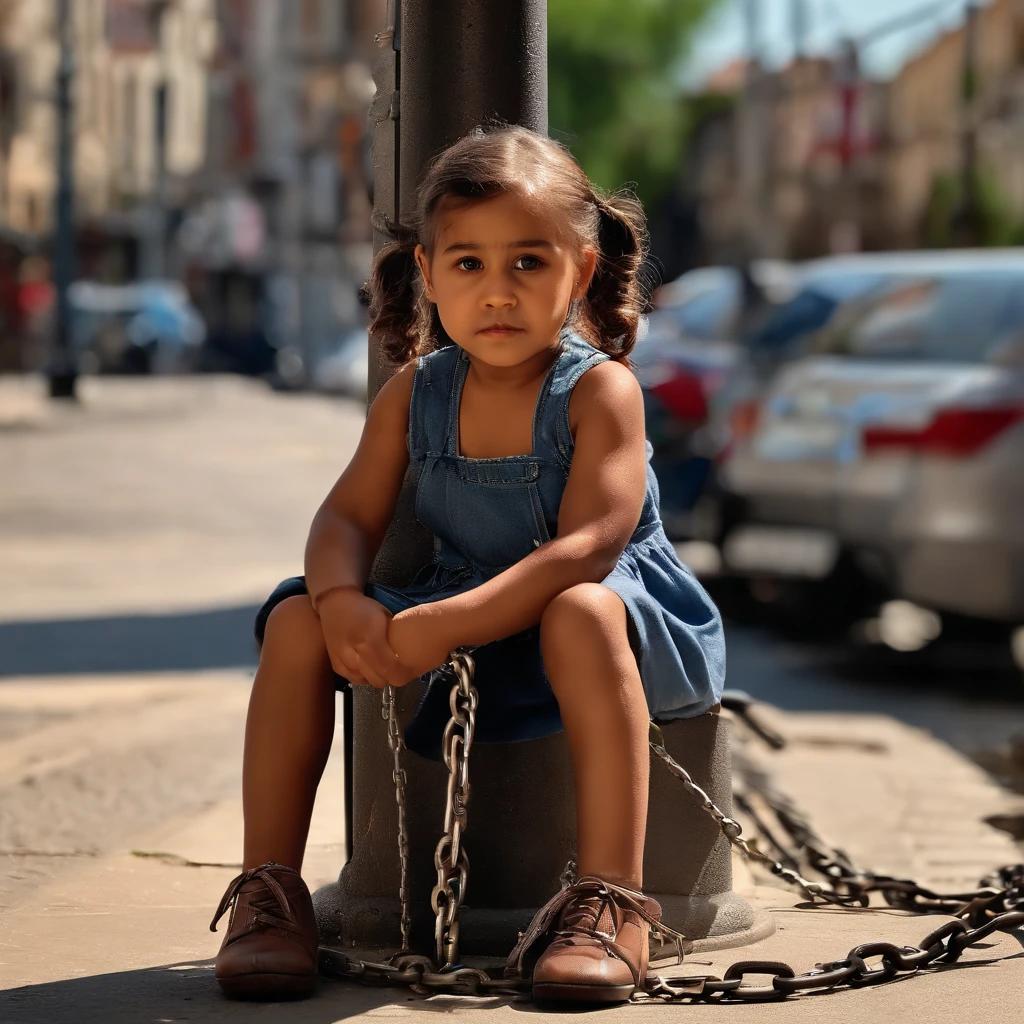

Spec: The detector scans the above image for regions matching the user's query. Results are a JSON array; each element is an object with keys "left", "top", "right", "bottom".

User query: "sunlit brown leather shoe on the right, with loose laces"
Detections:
[{"left": 506, "top": 876, "right": 674, "bottom": 1002}]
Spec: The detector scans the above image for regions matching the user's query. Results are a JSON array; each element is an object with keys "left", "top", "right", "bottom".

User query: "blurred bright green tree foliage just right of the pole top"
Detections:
[{"left": 548, "top": 0, "right": 718, "bottom": 203}]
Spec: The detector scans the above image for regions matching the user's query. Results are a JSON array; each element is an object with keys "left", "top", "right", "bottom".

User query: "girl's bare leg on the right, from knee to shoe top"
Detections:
[{"left": 541, "top": 584, "right": 650, "bottom": 889}]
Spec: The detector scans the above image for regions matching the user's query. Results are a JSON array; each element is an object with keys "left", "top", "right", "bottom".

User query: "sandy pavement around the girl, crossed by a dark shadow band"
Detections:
[{"left": 6, "top": 378, "right": 1024, "bottom": 1022}]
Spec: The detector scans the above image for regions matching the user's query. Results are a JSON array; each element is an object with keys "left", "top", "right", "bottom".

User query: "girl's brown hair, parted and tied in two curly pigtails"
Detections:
[{"left": 366, "top": 127, "right": 647, "bottom": 364}]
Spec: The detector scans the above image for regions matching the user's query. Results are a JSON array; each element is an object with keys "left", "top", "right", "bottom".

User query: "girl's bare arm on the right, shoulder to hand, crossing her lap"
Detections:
[{"left": 388, "top": 361, "right": 647, "bottom": 671}]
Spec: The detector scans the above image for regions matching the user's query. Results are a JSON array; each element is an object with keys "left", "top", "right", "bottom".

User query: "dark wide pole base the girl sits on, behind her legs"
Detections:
[{"left": 313, "top": 689, "right": 774, "bottom": 956}]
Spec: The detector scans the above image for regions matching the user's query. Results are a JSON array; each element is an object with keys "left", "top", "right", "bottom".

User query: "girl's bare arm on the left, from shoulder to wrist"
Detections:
[{"left": 305, "top": 366, "right": 415, "bottom": 607}]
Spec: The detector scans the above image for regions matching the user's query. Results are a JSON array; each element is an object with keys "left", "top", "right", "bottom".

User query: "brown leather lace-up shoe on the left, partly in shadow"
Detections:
[{"left": 210, "top": 861, "right": 319, "bottom": 998}]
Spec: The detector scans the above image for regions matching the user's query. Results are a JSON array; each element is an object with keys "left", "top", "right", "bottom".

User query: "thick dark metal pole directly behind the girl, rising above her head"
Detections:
[{"left": 329, "top": 0, "right": 548, "bottom": 936}]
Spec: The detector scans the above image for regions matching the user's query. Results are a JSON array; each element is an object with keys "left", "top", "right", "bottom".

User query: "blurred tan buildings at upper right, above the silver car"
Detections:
[{"left": 684, "top": 0, "right": 1024, "bottom": 261}]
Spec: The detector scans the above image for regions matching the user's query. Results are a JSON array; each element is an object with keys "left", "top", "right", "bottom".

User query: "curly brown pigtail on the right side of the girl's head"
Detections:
[{"left": 581, "top": 193, "right": 647, "bottom": 362}]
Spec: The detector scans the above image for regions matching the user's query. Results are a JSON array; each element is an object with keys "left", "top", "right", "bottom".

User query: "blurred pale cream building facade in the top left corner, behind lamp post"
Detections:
[{"left": 0, "top": 0, "right": 216, "bottom": 262}]
